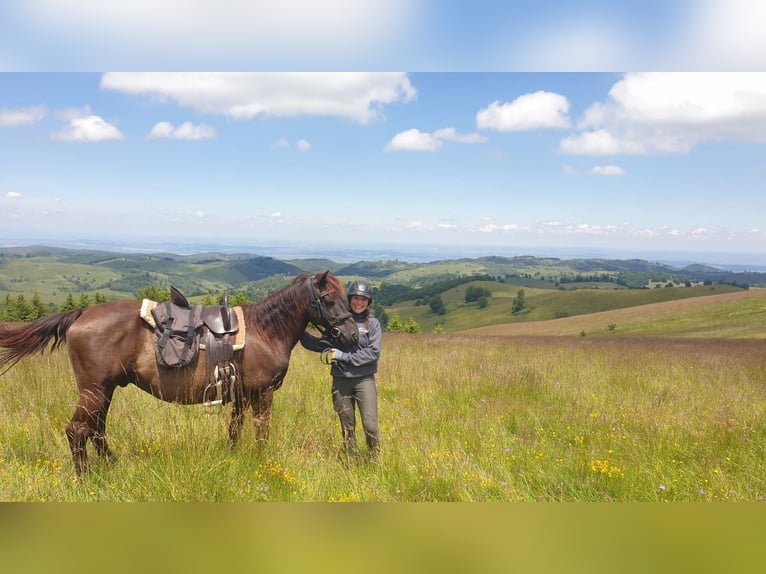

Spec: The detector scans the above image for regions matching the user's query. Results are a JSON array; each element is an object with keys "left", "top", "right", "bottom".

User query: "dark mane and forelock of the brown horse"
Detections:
[{"left": 242, "top": 273, "right": 344, "bottom": 339}]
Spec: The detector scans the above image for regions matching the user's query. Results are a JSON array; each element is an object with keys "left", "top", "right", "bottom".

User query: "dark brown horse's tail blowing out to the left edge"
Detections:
[{"left": 0, "top": 309, "right": 83, "bottom": 375}]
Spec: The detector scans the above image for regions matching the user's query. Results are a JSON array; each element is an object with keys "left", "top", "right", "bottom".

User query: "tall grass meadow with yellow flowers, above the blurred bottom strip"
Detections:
[{"left": 0, "top": 333, "right": 766, "bottom": 501}]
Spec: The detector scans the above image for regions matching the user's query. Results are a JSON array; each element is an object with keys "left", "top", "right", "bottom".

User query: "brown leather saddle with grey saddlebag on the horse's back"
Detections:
[{"left": 148, "top": 286, "right": 244, "bottom": 406}]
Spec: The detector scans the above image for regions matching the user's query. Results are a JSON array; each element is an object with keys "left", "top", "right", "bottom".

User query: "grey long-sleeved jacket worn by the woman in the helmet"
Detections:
[{"left": 301, "top": 316, "right": 382, "bottom": 378}]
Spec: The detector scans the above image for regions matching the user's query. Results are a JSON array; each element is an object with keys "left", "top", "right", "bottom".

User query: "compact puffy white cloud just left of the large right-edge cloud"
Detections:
[{"left": 476, "top": 91, "right": 570, "bottom": 132}]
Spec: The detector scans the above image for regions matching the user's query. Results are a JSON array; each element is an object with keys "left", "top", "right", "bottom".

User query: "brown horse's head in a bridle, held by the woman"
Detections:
[{"left": 306, "top": 269, "right": 359, "bottom": 344}]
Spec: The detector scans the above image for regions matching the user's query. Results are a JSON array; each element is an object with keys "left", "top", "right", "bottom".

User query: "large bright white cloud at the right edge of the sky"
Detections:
[{"left": 559, "top": 73, "right": 766, "bottom": 155}]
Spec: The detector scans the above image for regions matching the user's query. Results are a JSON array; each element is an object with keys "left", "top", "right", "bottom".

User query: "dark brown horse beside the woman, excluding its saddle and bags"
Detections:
[{"left": 0, "top": 269, "right": 359, "bottom": 478}]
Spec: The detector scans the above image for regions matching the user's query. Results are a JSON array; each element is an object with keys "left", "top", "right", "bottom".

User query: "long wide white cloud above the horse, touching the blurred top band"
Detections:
[{"left": 101, "top": 72, "right": 417, "bottom": 124}]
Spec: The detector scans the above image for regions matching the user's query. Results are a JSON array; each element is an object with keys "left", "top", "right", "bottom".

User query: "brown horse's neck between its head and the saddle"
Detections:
[{"left": 246, "top": 281, "right": 311, "bottom": 349}]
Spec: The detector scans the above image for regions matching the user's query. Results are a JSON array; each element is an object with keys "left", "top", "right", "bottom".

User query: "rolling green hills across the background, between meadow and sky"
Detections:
[{"left": 0, "top": 246, "right": 766, "bottom": 334}]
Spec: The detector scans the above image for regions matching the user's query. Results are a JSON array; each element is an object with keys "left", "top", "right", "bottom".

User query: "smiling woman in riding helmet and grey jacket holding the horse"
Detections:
[{"left": 301, "top": 281, "right": 382, "bottom": 458}]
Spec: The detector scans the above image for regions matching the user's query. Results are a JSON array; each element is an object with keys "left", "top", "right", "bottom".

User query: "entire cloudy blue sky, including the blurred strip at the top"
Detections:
[{"left": 0, "top": 0, "right": 766, "bottom": 259}]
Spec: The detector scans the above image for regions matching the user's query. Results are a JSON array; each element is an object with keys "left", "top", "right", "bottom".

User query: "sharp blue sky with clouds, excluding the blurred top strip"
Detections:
[{"left": 0, "top": 72, "right": 766, "bottom": 264}]
